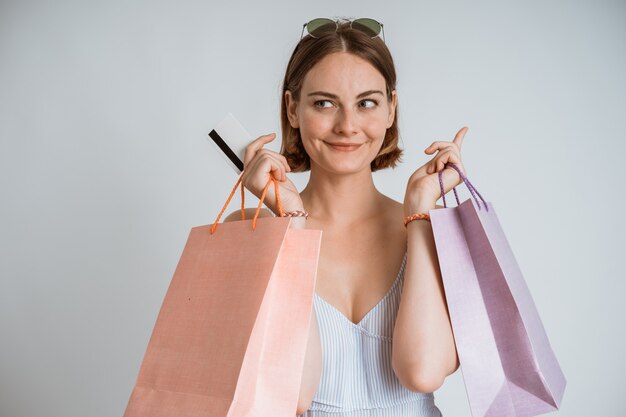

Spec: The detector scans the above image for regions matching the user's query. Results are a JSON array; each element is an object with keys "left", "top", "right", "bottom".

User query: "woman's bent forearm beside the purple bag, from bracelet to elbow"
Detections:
[{"left": 392, "top": 200, "right": 459, "bottom": 392}]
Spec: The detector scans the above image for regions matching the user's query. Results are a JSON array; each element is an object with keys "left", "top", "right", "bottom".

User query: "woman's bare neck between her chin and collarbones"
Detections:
[{"left": 300, "top": 164, "right": 384, "bottom": 224}]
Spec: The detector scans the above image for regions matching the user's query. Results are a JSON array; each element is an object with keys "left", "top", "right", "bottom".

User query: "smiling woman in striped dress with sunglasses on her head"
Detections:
[{"left": 227, "top": 19, "right": 467, "bottom": 417}]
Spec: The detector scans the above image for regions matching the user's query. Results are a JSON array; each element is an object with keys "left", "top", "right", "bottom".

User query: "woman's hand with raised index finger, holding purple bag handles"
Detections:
[{"left": 404, "top": 127, "right": 468, "bottom": 216}]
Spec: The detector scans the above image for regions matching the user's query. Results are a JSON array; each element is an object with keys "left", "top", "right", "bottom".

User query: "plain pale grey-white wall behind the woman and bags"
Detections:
[{"left": 0, "top": 0, "right": 626, "bottom": 417}]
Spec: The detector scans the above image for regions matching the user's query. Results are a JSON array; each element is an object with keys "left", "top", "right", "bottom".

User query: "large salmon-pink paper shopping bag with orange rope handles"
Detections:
[{"left": 124, "top": 177, "right": 321, "bottom": 417}]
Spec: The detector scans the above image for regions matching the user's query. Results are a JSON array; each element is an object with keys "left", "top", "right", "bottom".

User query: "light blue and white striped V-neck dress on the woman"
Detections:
[{"left": 300, "top": 254, "right": 441, "bottom": 417}]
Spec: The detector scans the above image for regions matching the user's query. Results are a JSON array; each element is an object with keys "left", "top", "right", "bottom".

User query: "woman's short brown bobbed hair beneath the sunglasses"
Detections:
[{"left": 280, "top": 22, "right": 402, "bottom": 172}]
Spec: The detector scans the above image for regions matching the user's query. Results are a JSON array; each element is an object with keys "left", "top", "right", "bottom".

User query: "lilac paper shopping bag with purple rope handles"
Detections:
[{"left": 429, "top": 164, "right": 566, "bottom": 417}]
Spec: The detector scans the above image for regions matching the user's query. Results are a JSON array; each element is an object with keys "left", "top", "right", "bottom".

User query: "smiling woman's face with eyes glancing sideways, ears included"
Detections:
[{"left": 285, "top": 52, "right": 397, "bottom": 174}]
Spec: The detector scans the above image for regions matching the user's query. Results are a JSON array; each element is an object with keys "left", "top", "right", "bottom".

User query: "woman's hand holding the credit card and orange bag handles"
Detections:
[{"left": 242, "top": 133, "right": 304, "bottom": 216}]
